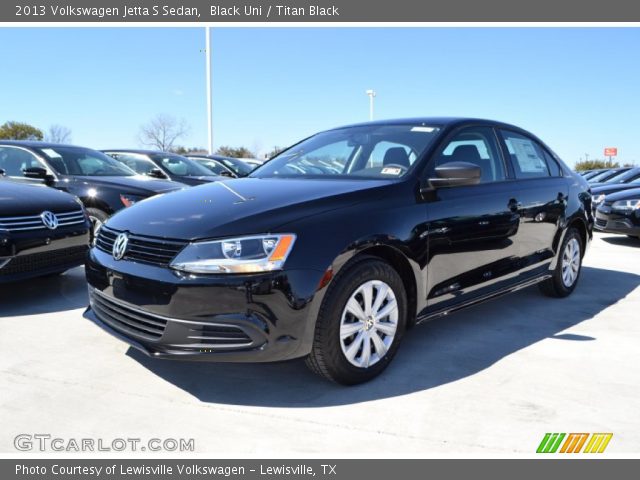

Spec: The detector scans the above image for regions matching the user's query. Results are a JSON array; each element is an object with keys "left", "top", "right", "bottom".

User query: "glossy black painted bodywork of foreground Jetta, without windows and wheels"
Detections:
[{"left": 85, "top": 118, "right": 593, "bottom": 361}]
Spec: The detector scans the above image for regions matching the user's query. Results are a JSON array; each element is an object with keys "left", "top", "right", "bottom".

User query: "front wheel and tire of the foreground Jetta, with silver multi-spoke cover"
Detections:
[{"left": 306, "top": 256, "right": 407, "bottom": 385}]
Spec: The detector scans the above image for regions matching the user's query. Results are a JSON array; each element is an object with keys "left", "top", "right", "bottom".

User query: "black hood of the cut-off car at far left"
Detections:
[{"left": 0, "top": 180, "right": 80, "bottom": 217}]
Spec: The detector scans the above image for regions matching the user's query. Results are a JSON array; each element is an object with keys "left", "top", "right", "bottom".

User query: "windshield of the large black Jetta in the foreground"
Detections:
[{"left": 250, "top": 125, "right": 440, "bottom": 179}]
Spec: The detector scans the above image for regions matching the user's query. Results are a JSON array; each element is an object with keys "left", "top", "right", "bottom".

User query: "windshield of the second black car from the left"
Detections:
[{"left": 38, "top": 146, "right": 136, "bottom": 177}]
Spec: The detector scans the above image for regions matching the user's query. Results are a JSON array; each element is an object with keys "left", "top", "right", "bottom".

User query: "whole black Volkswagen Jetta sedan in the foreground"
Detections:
[{"left": 85, "top": 118, "right": 593, "bottom": 384}]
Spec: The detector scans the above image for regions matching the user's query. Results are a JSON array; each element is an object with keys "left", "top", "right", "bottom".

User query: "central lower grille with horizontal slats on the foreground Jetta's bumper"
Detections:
[{"left": 90, "top": 290, "right": 167, "bottom": 340}]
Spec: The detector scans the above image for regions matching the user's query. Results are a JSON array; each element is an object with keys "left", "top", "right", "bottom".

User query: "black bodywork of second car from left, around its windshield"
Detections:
[{"left": 0, "top": 140, "right": 184, "bottom": 215}]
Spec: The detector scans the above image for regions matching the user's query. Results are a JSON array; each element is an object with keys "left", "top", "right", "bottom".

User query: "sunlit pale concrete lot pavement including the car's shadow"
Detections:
[{"left": 0, "top": 234, "right": 640, "bottom": 457}]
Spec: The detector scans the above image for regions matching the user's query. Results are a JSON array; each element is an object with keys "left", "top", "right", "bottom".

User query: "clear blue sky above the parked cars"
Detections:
[{"left": 0, "top": 27, "right": 640, "bottom": 165}]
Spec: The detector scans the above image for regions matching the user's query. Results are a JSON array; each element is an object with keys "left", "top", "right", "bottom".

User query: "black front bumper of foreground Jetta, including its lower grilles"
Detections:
[{"left": 84, "top": 248, "right": 323, "bottom": 362}]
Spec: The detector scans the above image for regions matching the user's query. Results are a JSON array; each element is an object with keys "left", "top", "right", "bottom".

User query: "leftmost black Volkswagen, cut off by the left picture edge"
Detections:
[{"left": 0, "top": 176, "right": 91, "bottom": 283}]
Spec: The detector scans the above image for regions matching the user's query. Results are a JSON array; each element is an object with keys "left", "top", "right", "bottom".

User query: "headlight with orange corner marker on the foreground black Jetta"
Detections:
[{"left": 171, "top": 233, "right": 296, "bottom": 273}]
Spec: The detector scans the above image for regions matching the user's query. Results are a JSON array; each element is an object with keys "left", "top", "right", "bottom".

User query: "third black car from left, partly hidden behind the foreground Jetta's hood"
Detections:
[{"left": 103, "top": 149, "right": 222, "bottom": 186}]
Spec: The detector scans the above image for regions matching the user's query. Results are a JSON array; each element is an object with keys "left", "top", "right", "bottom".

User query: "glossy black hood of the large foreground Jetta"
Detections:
[{"left": 107, "top": 178, "right": 395, "bottom": 240}]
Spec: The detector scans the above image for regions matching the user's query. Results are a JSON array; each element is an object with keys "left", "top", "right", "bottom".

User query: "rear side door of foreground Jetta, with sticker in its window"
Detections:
[{"left": 499, "top": 130, "right": 569, "bottom": 271}]
